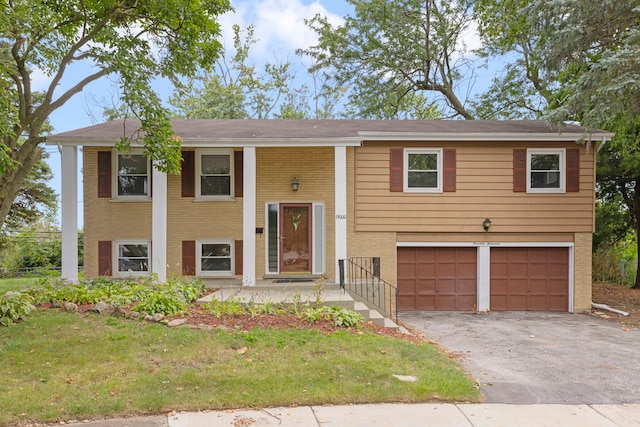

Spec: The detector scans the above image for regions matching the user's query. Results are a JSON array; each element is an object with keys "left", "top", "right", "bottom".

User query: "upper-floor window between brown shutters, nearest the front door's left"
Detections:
[{"left": 196, "top": 150, "right": 233, "bottom": 198}]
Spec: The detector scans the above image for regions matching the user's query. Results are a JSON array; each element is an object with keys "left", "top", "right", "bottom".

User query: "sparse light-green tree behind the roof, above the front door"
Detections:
[{"left": 170, "top": 25, "right": 343, "bottom": 119}]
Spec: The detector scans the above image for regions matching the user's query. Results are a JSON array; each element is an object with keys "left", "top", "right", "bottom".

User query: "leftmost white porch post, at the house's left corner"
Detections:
[{"left": 60, "top": 145, "right": 78, "bottom": 283}]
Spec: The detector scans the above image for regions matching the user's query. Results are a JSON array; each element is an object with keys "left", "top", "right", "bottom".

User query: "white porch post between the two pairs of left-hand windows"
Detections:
[{"left": 151, "top": 167, "right": 167, "bottom": 283}]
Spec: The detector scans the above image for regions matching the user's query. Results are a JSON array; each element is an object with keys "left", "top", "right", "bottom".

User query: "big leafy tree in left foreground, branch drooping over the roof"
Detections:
[{"left": 0, "top": 0, "right": 230, "bottom": 227}]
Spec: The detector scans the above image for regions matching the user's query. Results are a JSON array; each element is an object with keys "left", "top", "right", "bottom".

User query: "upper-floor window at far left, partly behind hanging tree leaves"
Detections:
[{"left": 115, "top": 153, "right": 150, "bottom": 198}]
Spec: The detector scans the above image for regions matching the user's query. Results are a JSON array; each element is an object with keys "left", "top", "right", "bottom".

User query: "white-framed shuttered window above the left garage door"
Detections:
[{"left": 404, "top": 149, "right": 442, "bottom": 193}]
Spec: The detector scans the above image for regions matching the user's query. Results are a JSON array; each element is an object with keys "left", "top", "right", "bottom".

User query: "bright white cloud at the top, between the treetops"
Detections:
[{"left": 220, "top": 0, "right": 343, "bottom": 62}]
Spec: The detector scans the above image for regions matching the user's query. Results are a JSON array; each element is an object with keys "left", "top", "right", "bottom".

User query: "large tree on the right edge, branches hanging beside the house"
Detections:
[{"left": 531, "top": 0, "right": 640, "bottom": 289}]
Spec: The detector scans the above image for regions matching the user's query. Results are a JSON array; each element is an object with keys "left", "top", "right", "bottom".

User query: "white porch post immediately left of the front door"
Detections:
[{"left": 242, "top": 147, "right": 257, "bottom": 286}]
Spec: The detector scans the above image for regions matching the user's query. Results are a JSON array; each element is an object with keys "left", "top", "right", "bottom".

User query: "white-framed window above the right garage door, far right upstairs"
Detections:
[{"left": 527, "top": 149, "right": 565, "bottom": 193}]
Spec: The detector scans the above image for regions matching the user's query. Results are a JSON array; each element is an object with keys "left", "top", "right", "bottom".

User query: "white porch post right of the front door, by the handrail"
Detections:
[{"left": 334, "top": 147, "right": 347, "bottom": 283}]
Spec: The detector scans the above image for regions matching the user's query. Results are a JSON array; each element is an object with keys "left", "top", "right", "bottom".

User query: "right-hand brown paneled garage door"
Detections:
[{"left": 490, "top": 248, "right": 569, "bottom": 311}]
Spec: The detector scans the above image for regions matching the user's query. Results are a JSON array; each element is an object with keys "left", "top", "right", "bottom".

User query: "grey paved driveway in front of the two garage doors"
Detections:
[{"left": 400, "top": 312, "right": 640, "bottom": 404}]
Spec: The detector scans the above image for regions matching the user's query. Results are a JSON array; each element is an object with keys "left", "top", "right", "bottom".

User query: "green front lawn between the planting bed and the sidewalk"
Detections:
[{"left": 0, "top": 310, "right": 480, "bottom": 425}]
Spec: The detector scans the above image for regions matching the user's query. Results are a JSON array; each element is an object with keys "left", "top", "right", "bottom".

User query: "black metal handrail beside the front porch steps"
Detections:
[{"left": 340, "top": 257, "right": 398, "bottom": 322}]
